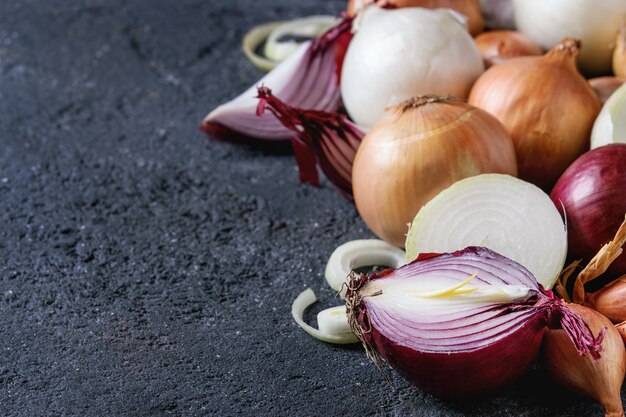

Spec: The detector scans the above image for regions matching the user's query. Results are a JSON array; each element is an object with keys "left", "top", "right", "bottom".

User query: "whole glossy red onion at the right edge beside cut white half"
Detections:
[{"left": 550, "top": 144, "right": 626, "bottom": 276}]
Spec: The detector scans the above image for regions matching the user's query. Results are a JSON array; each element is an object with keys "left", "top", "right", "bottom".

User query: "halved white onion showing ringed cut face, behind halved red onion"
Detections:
[{"left": 406, "top": 174, "right": 567, "bottom": 289}]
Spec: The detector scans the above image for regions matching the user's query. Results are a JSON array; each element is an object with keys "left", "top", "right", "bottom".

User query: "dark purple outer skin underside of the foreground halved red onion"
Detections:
[{"left": 360, "top": 308, "right": 545, "bottom": 400}]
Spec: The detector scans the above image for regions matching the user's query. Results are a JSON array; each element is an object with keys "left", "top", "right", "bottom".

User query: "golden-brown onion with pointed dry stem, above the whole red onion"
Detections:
[{"left": 469, "top": 39, "right": 601, "bottom": 190}]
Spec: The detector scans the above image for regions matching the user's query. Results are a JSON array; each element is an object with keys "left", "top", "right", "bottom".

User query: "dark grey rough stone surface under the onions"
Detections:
[{"left": 0, "top": 0, "right": 620, "bottom": 416}]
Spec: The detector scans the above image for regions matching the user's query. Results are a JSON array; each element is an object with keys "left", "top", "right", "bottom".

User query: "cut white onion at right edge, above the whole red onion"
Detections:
[{"left": 591, "top": 84, "right": 626, "bottom": 149}]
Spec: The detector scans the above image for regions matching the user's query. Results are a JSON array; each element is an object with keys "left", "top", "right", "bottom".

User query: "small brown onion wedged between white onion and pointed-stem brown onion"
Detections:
[{"left": 476, "top": 30, "right": 543, "bottom": 68}]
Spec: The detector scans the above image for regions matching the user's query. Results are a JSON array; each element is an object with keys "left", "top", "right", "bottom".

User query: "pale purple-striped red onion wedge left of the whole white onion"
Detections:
[{"left": 202, "top": 17, "right": 353, "bottom": 140}]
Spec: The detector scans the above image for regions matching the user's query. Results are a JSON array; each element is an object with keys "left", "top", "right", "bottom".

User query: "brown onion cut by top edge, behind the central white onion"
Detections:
[{"left": 348, "top": 0, "right": 485, "bottom": 36}]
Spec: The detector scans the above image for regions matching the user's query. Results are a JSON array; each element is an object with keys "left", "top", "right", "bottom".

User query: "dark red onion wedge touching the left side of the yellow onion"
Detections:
[{"left": 257, "top": 86, "right": 365, "bottom": 201}]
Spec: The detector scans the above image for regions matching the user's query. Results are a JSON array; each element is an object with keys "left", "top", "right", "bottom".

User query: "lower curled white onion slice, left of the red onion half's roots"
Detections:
[{"left": 291, "top": 288, "right": 359, "bottom": 344}]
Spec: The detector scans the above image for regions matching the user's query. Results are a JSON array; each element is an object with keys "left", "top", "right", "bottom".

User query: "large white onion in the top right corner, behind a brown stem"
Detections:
[{"left": 513, "top": 0, "right": 626, "bottom": 75}]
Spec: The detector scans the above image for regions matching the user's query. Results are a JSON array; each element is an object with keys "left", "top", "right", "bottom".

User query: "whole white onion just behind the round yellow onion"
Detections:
[{"left": 341, "top": 8, "right": 483, "bottom": 127}]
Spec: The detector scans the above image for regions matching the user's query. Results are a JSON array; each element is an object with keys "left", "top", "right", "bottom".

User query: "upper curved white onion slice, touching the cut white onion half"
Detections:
[{"left": 325, "top": 239, "right": 406, "bottom": 298}]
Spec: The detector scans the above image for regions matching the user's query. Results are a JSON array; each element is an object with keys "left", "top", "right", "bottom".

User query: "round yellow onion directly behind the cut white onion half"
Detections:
[{"left": 352, "top": 96, "right": 517, "bottom": 247}]
